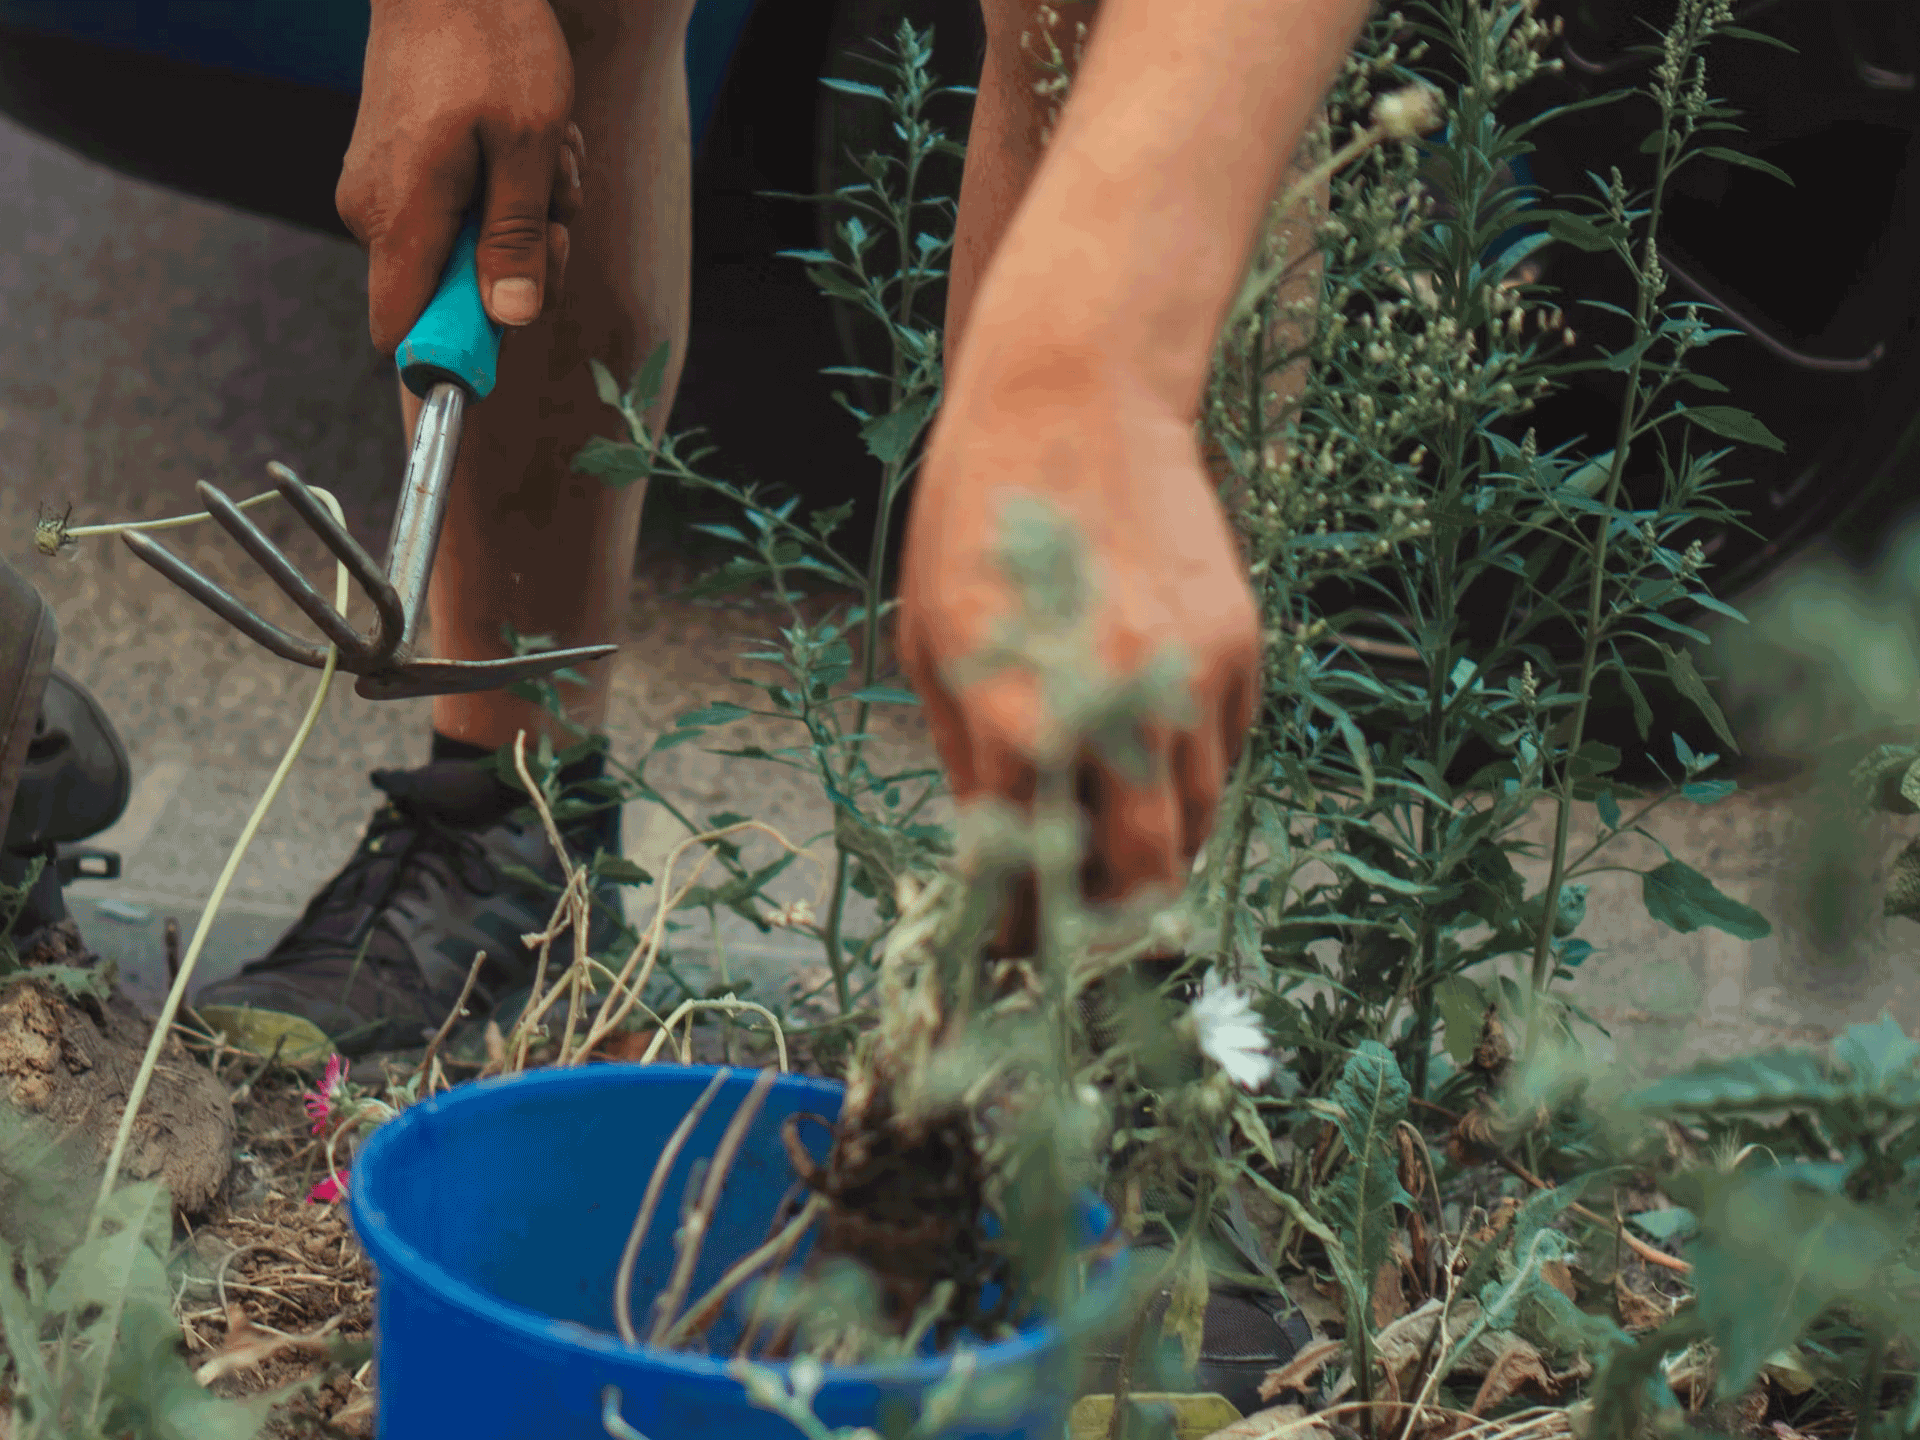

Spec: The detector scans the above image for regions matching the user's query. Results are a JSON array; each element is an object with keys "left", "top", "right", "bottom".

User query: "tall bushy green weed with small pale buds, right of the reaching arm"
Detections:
[{"left": 1206, "top": 0, "right": 1770, "bottom": 1128}]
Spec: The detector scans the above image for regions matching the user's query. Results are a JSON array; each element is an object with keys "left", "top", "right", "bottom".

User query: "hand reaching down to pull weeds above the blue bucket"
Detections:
[{"left": 899, "top": 351, "right": 1260, "bottom": 929}]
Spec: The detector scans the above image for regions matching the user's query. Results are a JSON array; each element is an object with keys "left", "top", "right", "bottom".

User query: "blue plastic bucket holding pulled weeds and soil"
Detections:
[{"left": 351, "top": 1066, "right": 1117, "bottom": 1440}]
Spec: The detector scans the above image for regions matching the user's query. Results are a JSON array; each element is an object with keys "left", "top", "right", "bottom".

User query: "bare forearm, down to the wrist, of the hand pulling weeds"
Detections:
[{"left": 952, "top": 0, "right": 1371, "bottom": 415}]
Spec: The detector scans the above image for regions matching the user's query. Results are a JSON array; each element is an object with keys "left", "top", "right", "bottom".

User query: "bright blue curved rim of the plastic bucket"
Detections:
[{"left": 348, "top": 1062, "right": 1125, "bottom": 1388}]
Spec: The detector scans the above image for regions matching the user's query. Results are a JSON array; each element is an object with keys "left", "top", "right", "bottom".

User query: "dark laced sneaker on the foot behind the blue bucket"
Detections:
[{"left": 194, "top": 760, "right": 620, "bottom": 1056}]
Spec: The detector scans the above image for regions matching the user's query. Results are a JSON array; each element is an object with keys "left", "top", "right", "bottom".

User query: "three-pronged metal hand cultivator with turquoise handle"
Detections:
[{"left": 123, "top": 213, "right": 618, "bottom": 701}]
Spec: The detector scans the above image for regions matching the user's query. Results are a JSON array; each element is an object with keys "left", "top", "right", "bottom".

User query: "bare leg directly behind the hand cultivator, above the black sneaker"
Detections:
[{"left": 401, "top": 0, "right": 693, "bottom": 749}]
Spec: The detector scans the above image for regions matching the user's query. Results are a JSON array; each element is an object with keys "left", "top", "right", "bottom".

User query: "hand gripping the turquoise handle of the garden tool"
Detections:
[{"left": 334, "top": 0, "right": 584, "bottom": 353}]
